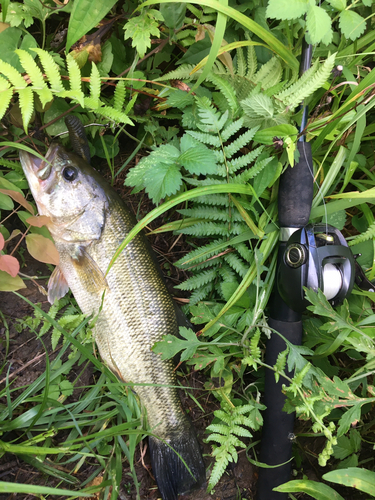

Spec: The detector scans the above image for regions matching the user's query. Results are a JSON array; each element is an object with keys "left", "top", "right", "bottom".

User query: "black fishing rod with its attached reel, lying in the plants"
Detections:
[{"left": 257, "top": 43, "right": 374, "bottom": 500}]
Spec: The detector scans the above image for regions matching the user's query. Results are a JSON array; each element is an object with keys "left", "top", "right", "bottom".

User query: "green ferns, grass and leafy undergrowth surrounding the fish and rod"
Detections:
[{"left": 0, "top": 0, "right": 375, "bottom": 500}]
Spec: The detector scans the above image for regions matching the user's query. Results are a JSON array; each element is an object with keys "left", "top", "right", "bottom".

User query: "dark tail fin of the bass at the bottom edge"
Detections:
[{"left": 149, "top": 425, "right": 206, "bottom": 500}]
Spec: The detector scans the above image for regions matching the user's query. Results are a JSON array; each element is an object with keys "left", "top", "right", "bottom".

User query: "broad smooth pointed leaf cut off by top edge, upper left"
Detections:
[{"left": 66, "top": 0, "right": 117, "bottom": 52}]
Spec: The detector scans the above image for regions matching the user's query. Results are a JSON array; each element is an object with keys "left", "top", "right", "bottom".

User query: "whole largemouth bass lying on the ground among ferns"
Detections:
[{"left": 20, "top": 125, "right": 205, "bottom": 500}]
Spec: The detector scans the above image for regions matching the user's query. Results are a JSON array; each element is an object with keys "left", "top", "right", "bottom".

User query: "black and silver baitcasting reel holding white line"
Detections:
[{"left": 277, "top": 224, "right": 356, "bottom": 312}]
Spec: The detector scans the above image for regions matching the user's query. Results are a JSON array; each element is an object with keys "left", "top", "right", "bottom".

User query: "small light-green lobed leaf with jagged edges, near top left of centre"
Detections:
[{"left": 124, "top": 10, "right": 160, "bottom": 57}]
